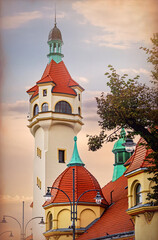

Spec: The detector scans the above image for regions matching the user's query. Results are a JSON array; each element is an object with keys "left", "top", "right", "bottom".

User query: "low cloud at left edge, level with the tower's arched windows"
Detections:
[{"left": 2, "top": 100, "right": 28, "bottom": 114}]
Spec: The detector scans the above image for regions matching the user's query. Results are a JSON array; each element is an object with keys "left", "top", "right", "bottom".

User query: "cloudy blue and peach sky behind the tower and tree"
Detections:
[{"left": 0, "top": 0, "right": 158, "bottom": 240}]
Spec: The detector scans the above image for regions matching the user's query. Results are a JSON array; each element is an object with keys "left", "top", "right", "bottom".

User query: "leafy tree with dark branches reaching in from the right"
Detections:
[{"left": 88, "top": 33, "right": 158, "bottom": 203}]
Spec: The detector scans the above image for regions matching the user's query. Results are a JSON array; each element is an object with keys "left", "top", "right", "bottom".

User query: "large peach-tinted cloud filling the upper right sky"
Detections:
[{"left": 73, "top": 0, "right": 158, "bottom": 49}]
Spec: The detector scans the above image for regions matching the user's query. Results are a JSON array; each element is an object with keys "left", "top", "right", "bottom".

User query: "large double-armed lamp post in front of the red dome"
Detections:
[{"left": 44, "top": 168, "right": 103, "bottom": 240}]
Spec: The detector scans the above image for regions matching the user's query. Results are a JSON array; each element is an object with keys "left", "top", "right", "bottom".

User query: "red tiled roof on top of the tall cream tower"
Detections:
[{"left": 27, "top": 60, "right": 84, "bottom": 99}]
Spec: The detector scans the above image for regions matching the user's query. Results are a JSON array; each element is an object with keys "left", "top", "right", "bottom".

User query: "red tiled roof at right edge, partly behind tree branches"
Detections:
[{"left": 124, "top": 138, "right": 152, "bottom": 174}]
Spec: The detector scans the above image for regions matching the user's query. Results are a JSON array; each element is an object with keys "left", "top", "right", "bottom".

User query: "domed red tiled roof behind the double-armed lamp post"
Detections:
[{"left": 43, "top": 166, "right": 108, "bottom": 206}]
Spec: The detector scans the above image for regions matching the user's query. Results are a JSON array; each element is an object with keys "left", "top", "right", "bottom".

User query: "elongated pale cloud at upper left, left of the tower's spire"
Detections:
[{"left": 1, "top": 11, "right": 43, "bottom": 29}]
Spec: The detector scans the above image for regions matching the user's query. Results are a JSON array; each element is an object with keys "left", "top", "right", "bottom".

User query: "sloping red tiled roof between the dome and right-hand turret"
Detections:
[{"left": 77, "top": 176, "right": 134, "bottom": 240}]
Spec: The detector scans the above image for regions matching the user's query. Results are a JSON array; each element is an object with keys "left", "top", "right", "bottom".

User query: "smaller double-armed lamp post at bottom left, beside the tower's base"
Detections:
[{"left": 1, "top": 215, "right": 45, "bottom": 240}]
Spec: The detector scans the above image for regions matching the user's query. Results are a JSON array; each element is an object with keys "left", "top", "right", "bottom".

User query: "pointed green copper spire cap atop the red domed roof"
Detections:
[{"left": 67, "top": 136, "right": 85, "bottom": 167}]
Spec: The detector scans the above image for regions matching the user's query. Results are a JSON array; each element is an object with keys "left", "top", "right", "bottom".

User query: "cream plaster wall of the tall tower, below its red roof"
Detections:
[{"left": 28, "top": 87, "right": 82, "bottom": 240}]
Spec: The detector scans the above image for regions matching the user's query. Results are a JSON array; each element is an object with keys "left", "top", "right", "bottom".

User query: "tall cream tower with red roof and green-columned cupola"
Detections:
[{"left": 27, "top": 20, "right": 84, "bottom": 240}]
